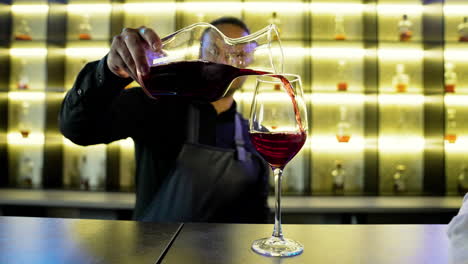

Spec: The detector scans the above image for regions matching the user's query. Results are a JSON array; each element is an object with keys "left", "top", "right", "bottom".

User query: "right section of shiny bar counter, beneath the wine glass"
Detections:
[{"left": 162, "top": 224, "right": 449, "bottom": 264}]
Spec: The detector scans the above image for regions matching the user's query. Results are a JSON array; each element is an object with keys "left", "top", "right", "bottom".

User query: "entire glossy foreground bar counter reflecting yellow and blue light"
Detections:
[{"left": 0, "top": 217, "right": 450, "bottom": 264}]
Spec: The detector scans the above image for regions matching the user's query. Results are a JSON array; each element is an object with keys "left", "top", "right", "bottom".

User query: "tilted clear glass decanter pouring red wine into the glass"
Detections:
[{"left": 138, "top": 23, "right": 283, "bottom": 102}]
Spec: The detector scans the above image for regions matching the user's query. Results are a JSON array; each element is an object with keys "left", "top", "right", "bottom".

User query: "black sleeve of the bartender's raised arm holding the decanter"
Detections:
[{"left": 59, "top": 56, "right": 140, "bottom": 145}]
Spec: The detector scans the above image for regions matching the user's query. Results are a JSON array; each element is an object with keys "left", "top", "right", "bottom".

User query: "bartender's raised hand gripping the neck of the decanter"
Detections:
[{"left": 107, "top": 26, "right": 161, "bottom": 81}]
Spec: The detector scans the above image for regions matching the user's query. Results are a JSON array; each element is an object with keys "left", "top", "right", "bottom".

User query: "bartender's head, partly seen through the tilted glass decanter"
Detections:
[{"left": 201, "top": 17, "right": 252, "bottom": 96}]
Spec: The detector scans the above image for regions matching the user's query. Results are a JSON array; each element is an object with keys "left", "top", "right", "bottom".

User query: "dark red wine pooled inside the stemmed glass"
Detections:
[{"left": 250, "top": 131, "right": 307, "bottom": 169}]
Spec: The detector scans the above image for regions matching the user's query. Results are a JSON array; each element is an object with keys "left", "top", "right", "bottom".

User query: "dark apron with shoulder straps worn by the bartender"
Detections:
[{"left": 141, "top": 106, "right": 268, "bottom": 223}]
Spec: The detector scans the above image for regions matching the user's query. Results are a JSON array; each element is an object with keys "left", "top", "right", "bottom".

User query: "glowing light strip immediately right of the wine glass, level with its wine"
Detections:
[{"left": 310, "top": 135, "right": 365, "bottom": 152}]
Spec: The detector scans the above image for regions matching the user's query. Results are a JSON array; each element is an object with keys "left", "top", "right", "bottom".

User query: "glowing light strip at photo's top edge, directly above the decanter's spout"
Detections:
[{"left": 245, "top": 2, "right": 308, "bottom": 13}]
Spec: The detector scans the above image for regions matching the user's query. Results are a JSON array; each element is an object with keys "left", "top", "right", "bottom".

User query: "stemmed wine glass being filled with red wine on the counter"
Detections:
[{"left": 249, "top": 74, "right": 307, "bottom": 257}]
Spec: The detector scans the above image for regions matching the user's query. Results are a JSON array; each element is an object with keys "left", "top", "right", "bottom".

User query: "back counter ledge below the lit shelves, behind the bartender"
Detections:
[{"left": 0, "top": 189, "right": 463, "bottom": 213}]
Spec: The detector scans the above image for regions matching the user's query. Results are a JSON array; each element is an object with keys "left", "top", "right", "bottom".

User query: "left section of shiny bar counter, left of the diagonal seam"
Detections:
[{"left": 0, "top": 217, "right": 182, "bottom": 264}]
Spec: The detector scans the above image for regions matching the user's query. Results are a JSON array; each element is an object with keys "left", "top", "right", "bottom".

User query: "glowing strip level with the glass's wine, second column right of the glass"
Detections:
[{"left": 379, "top": 135, "right": 425, "bottom": 153}]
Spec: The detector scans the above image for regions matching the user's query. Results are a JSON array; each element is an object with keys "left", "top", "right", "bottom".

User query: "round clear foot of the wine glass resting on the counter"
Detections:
[{"left": 252, "top": 237, "right": 304, "bottom": 257}]
